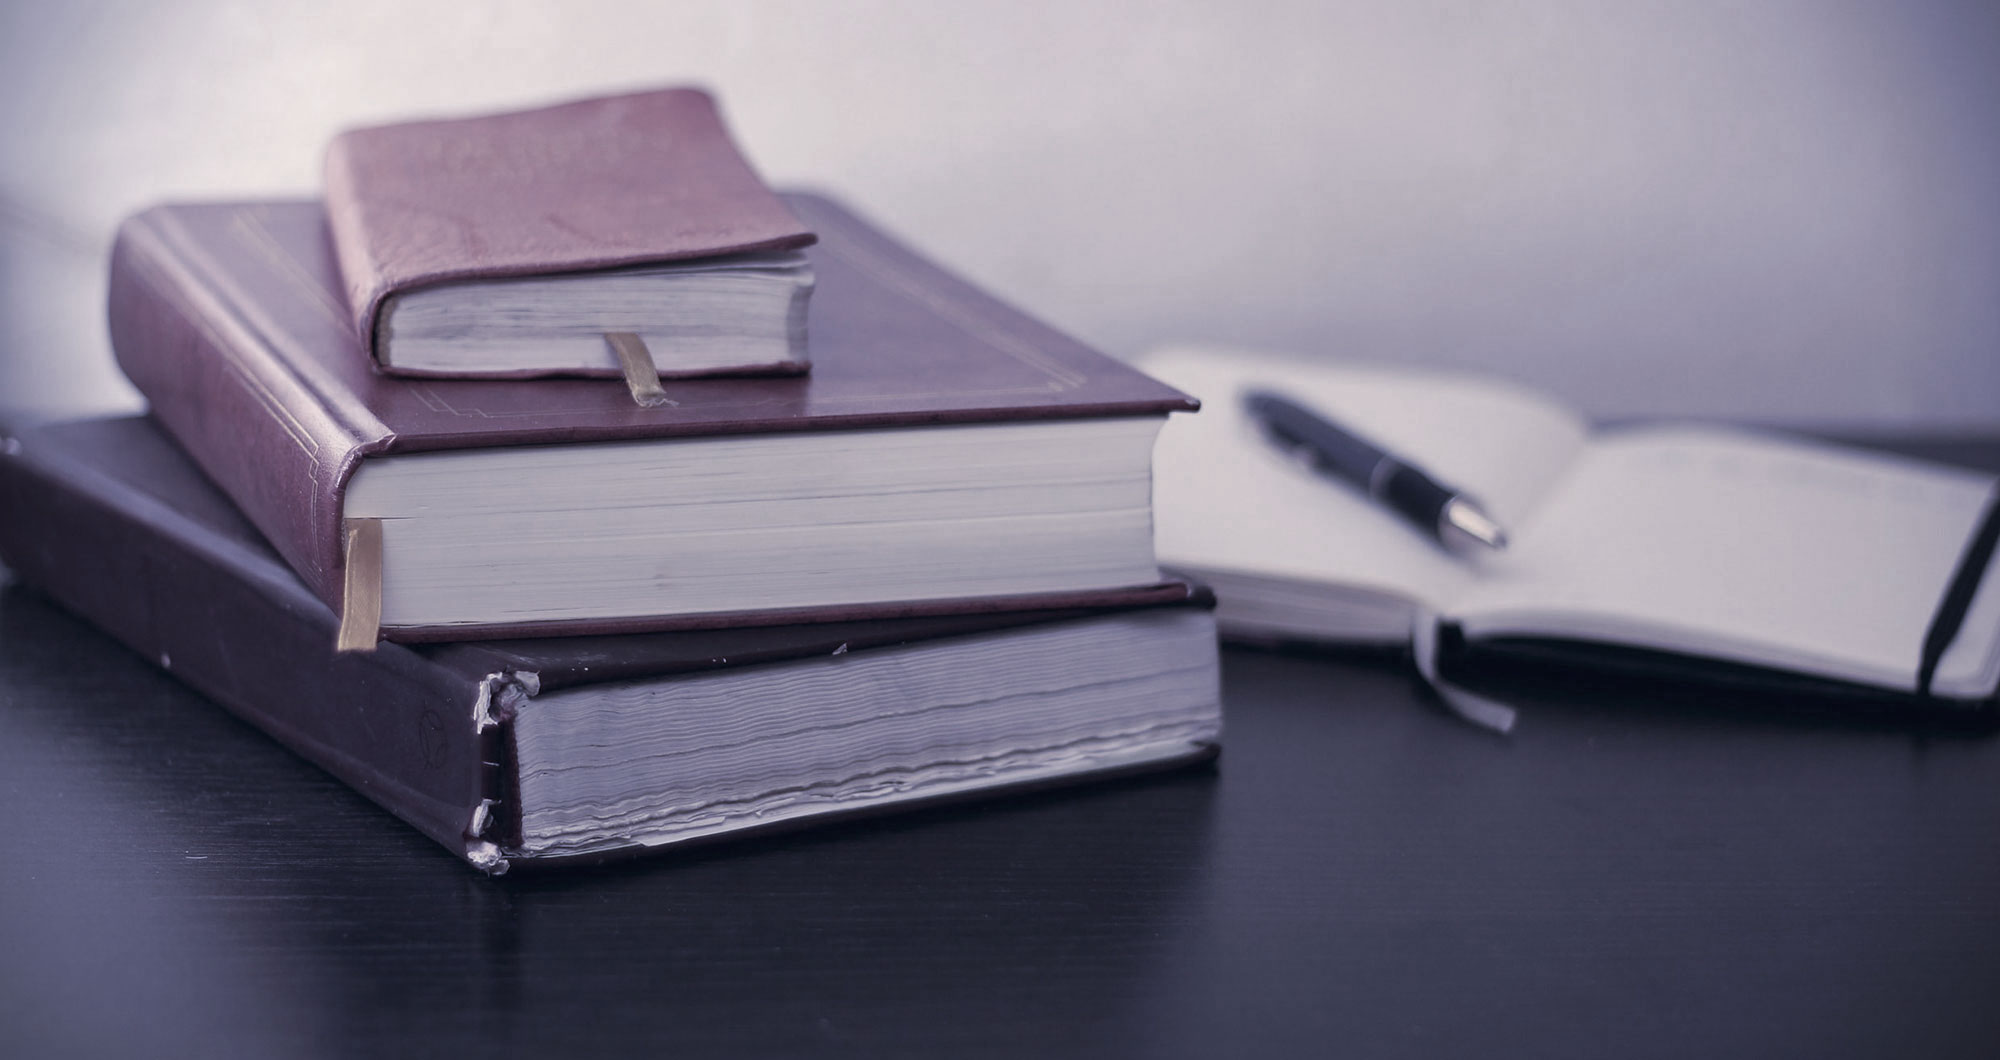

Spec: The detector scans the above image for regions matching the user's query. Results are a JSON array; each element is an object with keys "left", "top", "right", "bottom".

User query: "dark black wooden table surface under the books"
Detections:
[{"left": 0, "top": 424, "right": 2000, "bottom": 1058}]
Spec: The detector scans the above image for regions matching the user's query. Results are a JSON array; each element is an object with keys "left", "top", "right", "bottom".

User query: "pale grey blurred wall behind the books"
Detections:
[{"left": 0, "top": 0, "right": 2000, "bottom": 430}]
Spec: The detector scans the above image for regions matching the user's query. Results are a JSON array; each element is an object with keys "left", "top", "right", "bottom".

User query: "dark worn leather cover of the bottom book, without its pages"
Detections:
[{"left": 0, "top": 418, "right": 1212, "bottom": 872}]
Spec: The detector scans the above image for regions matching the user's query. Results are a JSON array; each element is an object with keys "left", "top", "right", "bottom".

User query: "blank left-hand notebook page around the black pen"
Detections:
[{"left": 1142, "top": 350, "right": 1584, "bottom": 606}]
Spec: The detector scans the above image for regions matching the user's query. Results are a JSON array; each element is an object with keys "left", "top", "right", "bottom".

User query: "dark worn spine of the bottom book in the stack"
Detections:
[{"left": 0, "top": 432, "right": 508, "bottom": 872}]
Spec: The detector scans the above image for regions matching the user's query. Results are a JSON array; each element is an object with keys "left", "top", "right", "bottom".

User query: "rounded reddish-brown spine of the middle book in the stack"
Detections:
[{"left": 108, "top": 210, "right": 380, "bottom": 608}]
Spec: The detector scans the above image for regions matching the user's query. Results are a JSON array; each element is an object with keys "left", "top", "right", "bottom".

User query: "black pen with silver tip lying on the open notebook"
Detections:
[{"left": 1244, "top": 390, "right": 1506, "bottom": 548}]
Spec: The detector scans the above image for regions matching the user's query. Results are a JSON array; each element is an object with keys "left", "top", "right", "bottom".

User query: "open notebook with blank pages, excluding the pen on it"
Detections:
[{"left": 1142, "top": 350, "right": 2000, "bottom": 702}]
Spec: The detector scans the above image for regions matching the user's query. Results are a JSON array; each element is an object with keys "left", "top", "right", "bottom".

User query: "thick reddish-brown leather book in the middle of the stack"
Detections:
[{"left": 110, "top": 196, "right": 1196, "bottom": 642}]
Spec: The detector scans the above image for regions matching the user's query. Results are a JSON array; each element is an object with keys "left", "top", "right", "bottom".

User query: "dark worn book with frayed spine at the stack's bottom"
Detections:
[{"left": 0, "top": 418, "right": 1220, "bottom": 872}]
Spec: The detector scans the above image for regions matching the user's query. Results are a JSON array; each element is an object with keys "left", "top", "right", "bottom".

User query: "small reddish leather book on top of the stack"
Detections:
[{"left": 326, "top": 88, "right": 812, "bottom": 378}]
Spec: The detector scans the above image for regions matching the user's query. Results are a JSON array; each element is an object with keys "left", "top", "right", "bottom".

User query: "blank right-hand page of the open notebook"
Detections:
[{"left": 1448, "top": 428, "right": 2000, "bottom": 696}]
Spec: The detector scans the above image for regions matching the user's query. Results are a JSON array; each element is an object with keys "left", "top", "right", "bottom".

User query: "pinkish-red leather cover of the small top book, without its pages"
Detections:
[{"left": 326, "top": 88, "right": 812, "bottom": 358}]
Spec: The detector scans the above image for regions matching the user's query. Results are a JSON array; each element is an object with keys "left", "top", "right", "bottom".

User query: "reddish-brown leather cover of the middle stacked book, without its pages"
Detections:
[{"left": 110, "top": 196, "right": 1198, "bottom": 640}]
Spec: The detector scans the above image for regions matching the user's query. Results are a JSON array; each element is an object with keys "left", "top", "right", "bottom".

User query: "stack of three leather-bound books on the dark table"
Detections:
[{"left": 0, "top": 90, "right": 1220, "bottom": 872}]
